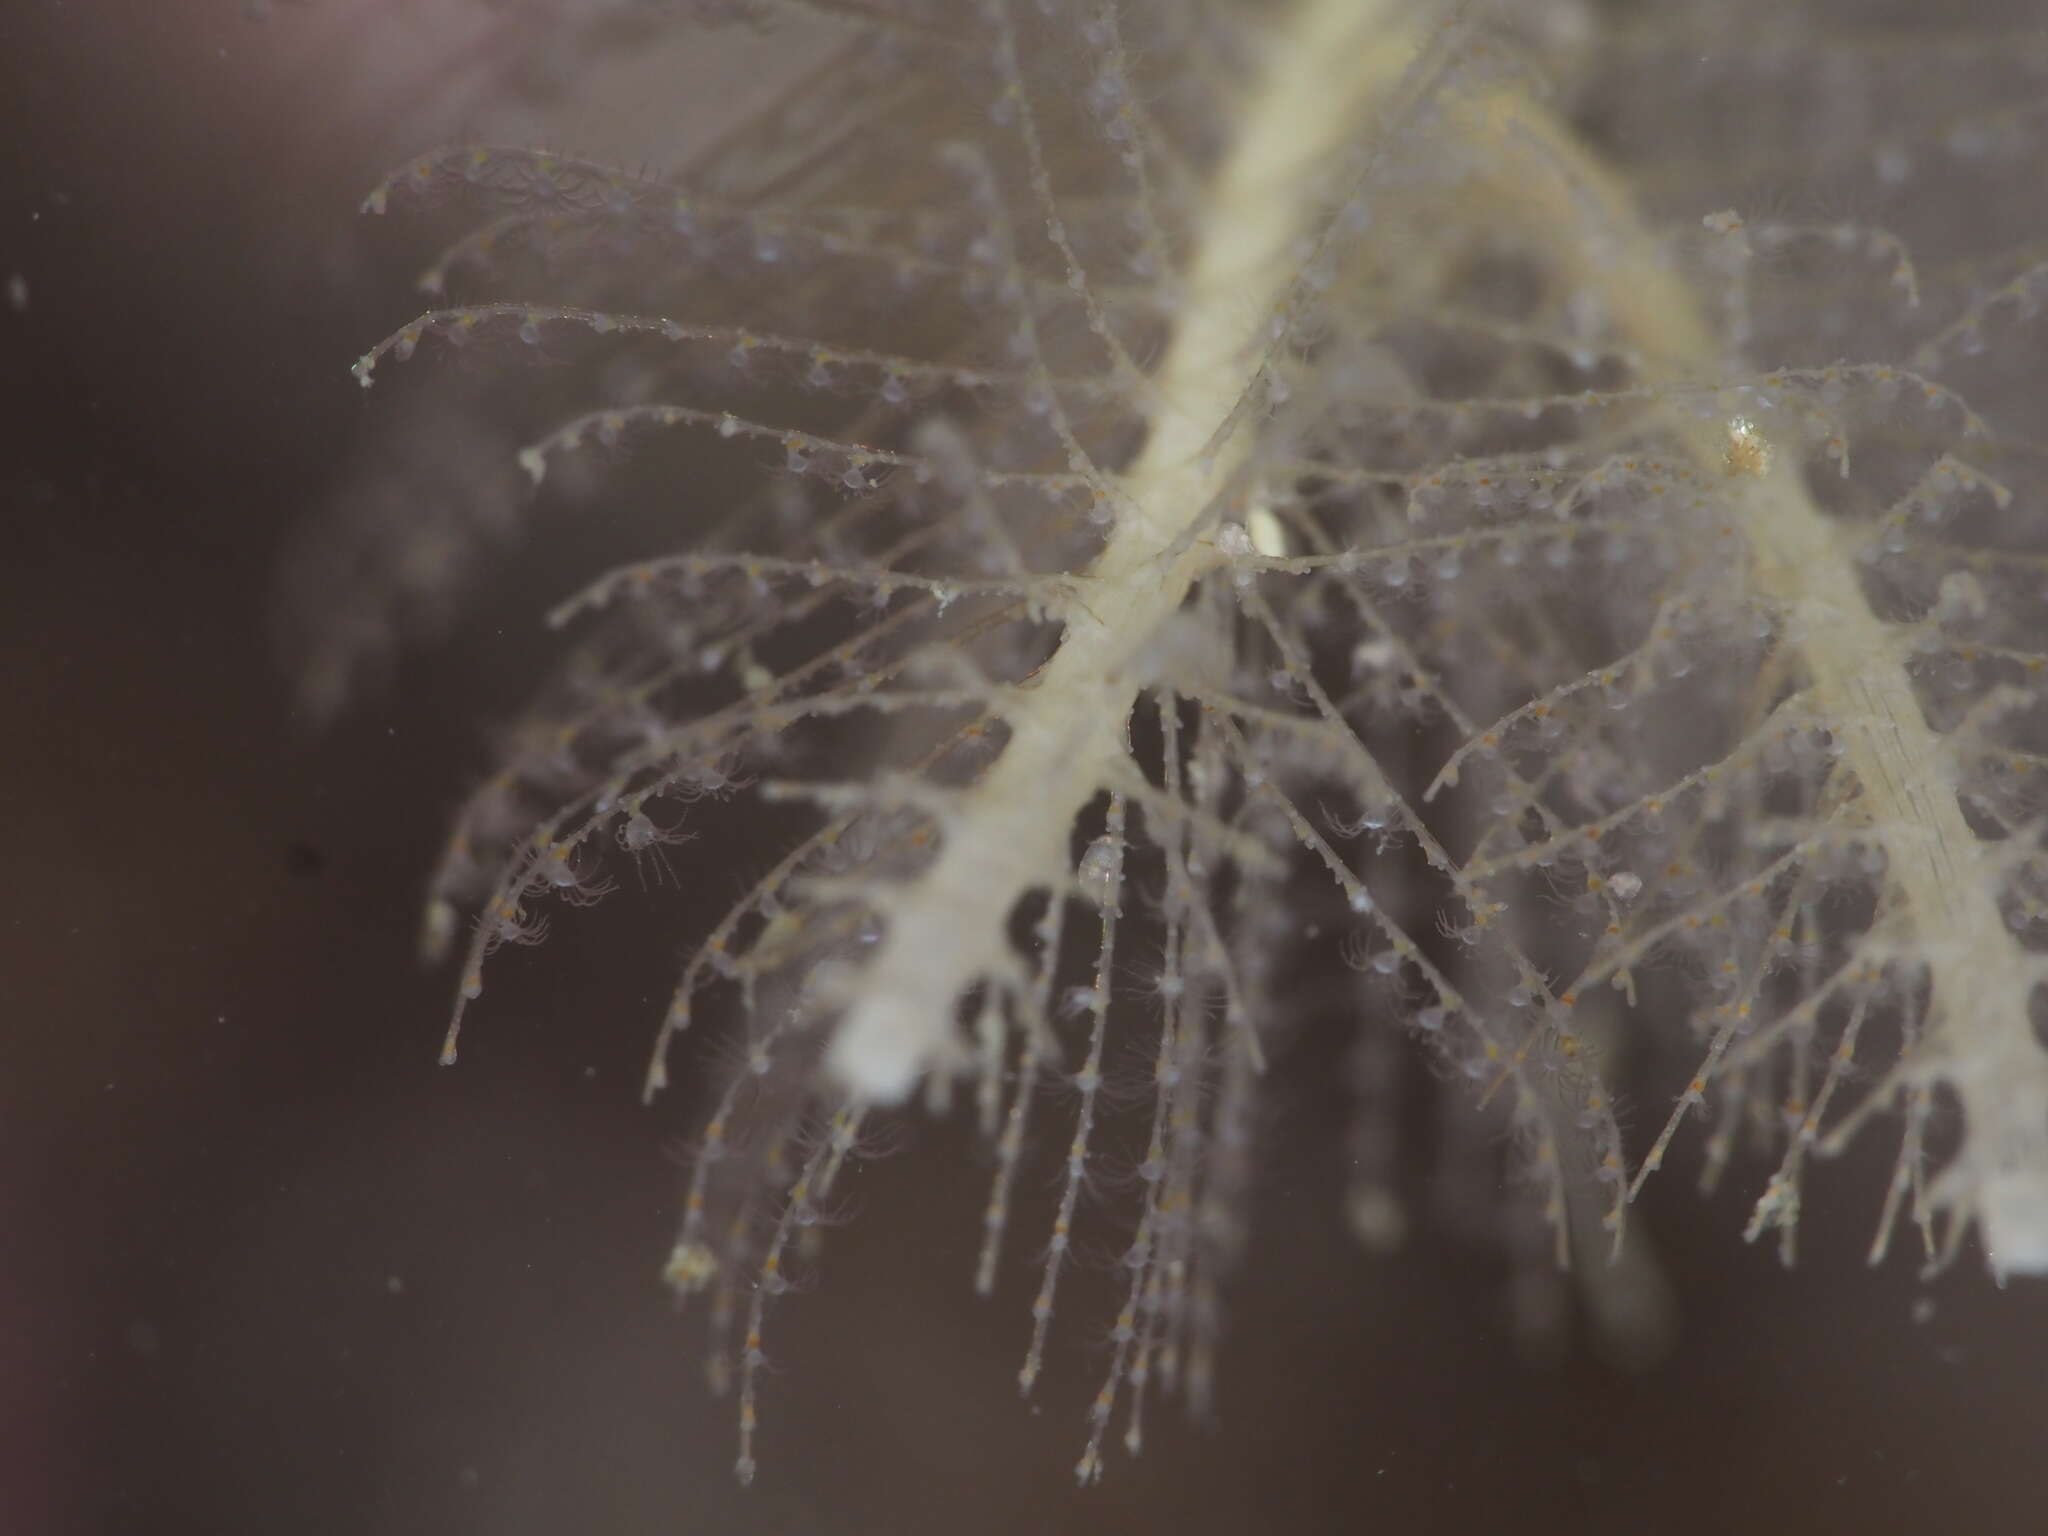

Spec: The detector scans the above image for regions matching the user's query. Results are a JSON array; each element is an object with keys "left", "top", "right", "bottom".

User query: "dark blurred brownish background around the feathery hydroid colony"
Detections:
[{"left": 0, "top": 0, "right": 2048, "bottom": 1534}]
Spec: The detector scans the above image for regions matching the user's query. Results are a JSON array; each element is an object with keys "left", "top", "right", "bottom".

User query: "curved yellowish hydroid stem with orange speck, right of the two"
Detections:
[{"left": 1458, "top": 92, "right": 2048, "bottom": 1276}]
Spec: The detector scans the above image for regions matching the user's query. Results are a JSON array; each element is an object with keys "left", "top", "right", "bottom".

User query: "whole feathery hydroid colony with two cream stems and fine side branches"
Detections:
[{"left": 335, "top": 0, "right": 2048, "bottom": 1479}]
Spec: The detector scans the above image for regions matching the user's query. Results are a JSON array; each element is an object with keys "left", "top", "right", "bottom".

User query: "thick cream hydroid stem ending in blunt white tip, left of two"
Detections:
[{"left": 829, "top": 0, "right": 1413, "bottom": 1102}]
